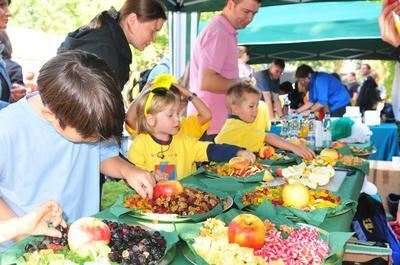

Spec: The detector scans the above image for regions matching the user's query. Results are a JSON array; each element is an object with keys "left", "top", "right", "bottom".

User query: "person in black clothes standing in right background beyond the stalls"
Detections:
[{"left": 356, "top": 63, "right": 381, "bottom": 113}]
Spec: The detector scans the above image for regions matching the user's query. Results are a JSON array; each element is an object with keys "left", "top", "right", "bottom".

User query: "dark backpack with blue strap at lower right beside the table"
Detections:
[{"left": 352, "top": 193, "right": 400, "bottom": 264}]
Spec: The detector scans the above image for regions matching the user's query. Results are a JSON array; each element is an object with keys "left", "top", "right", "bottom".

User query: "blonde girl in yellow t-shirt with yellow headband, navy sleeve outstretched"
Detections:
[{"left": 128, "top": 76, "right": 255, "bottom": 179}]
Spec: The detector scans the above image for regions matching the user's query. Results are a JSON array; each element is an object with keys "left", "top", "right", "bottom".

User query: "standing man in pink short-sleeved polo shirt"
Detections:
[{"left": 188, "top": 0, "right": 261, "bottom": 140}]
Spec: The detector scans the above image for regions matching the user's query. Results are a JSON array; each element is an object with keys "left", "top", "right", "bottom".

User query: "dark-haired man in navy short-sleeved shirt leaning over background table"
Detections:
[{"left": 255, "top": 59, "right": 285, "bottom": 120}]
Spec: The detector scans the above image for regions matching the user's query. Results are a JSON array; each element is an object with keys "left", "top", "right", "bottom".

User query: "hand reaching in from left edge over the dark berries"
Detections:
[{"left": 20, "top": 201, "right": 66, "bottom": 237}]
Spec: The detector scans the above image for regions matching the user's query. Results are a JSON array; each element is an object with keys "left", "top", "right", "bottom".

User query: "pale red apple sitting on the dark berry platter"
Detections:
[{"left": 68, "top": 217, "right": 111, "bottom": 258}]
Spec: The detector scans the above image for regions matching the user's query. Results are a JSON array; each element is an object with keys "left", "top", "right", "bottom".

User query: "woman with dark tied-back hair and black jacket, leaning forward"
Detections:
[{"left": 58, "top": 0, "right": 167, "bottom": 90}]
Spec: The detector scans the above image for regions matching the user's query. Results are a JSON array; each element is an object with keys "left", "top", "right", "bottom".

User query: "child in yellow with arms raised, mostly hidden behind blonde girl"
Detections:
[{"left": 125, "top": 74, "right": 211, "bottom": 139}]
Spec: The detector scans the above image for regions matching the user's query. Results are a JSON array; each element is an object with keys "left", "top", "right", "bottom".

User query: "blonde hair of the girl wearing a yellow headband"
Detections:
[{"left": 135, "top": 90, "right": 180, "bottom": 134}]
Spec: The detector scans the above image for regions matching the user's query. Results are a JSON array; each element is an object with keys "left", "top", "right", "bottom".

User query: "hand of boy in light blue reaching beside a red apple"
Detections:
[{"left": 124, "top": 166, "right": 156, "bottom": 198}]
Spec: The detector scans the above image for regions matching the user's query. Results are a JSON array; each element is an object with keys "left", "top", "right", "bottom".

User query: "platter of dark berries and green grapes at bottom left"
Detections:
[{"left": 17, "top": 217, "right": 177, "bottom": 265}]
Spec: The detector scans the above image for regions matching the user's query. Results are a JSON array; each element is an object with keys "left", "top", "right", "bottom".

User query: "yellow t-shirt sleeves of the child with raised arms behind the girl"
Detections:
[{"left": 125, "top": 113, "right": 211, "bottom": 139}]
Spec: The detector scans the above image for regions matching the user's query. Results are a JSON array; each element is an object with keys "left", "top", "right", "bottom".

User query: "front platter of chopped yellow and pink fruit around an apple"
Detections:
[{"left": 181, "top": 219, "right": 341, "bottom": 264}]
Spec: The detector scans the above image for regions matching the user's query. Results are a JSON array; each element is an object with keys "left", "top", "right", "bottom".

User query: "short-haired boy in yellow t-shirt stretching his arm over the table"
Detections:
[{"left": 215, "top": 81, "right": 315, "bottom": 159}]
